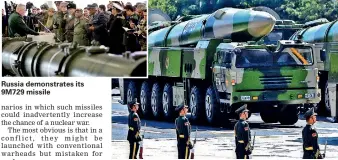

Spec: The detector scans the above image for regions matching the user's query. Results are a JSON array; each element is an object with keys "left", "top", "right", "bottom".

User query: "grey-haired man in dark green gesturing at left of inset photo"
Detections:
[{"left": 8, "top": 4, "right": 39, "bottom": 37}]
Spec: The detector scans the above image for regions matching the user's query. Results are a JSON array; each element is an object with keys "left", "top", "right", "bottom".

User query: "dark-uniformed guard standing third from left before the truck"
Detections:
[{"left": 234, "top": 104, "right": 253, "bottom": 159}]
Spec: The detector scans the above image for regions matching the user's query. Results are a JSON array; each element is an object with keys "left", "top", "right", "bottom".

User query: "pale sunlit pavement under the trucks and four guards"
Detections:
[{"left": 112, "top": 97, "right": 338, "bottom": 159}]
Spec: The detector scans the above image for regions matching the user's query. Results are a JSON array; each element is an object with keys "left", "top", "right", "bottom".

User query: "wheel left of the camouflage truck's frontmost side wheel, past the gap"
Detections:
[{"left": 189, "top": 86, "right": 205, "bottom": 122}]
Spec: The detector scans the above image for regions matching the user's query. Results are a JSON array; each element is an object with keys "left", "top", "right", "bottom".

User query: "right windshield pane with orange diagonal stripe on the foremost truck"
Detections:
[{"left": 275, "top": 48, "right": 313, "bottom": 66}]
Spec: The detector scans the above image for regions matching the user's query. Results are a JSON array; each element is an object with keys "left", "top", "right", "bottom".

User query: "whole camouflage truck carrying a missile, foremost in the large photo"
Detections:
[{"left": 119, "top": 8, "right": 320, "bottom": 124}]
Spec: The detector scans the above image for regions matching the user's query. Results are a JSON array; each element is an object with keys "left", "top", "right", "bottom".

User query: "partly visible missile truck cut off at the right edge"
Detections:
[{"left": 291, "top": 20, "right": 338, "bottom": 119}]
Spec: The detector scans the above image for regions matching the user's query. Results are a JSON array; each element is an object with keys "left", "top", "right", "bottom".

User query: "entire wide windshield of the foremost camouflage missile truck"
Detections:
[{"left": 236, "top": 48, "right": 313, "bottom": 68}]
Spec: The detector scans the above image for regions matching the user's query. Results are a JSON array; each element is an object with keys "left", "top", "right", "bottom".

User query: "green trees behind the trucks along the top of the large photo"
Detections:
[{"left": 149, "top": 0, "right": 338, "bottom": 23}]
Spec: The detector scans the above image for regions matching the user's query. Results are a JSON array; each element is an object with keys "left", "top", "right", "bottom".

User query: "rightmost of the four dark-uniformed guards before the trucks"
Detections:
[{"left": 302, "top": 108, "right": 325, "bottom": 159}]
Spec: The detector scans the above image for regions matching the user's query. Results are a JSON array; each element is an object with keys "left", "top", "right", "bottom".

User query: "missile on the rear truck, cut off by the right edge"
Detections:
[{"left": 290, "top": 20, "right": 338, "bottom": 43}]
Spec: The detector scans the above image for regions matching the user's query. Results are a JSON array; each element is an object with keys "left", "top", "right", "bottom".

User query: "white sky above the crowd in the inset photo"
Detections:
[{"left": 8, "top": 0, "right": 146, "bottom": 8}]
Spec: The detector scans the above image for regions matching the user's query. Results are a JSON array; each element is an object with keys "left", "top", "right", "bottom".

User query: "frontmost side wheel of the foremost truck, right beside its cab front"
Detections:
[{"left": 205, "top": 87, "right": 220, "bottom": 125}]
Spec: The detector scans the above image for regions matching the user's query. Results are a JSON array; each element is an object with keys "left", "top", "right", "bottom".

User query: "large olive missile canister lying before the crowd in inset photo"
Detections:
[{"left": 2, "top": 38, "right": 147, "bottom": 77}]
